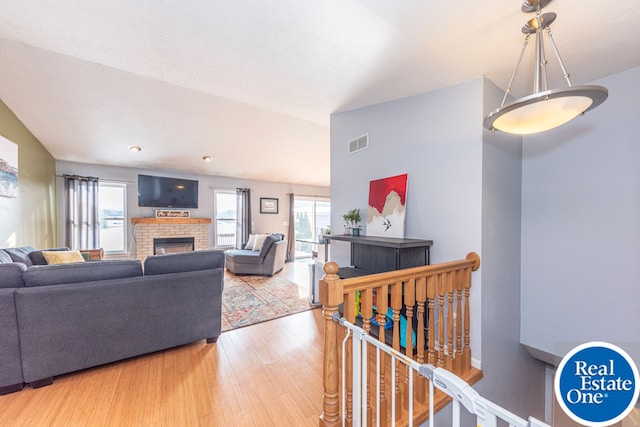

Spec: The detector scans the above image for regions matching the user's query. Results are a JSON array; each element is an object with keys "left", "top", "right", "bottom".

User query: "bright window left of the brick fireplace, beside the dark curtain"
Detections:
[{"left": 98, "top": 181, "right": 127, "bottom": 253}]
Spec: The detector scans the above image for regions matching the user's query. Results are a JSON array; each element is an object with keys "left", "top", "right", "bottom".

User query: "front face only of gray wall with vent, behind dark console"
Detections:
[{"left": 331, "top": 80, "right": 482, "bottom": 360}]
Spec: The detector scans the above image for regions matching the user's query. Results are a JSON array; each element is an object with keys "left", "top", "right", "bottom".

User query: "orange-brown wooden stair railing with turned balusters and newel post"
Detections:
[{"left": 319, "top": 252, "right": 482, "bottom": 427}]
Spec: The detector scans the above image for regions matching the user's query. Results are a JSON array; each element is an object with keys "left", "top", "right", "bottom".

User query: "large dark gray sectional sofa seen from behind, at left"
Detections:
[{"left": 0, "top": 247, "right": 224, "bottom": 394}]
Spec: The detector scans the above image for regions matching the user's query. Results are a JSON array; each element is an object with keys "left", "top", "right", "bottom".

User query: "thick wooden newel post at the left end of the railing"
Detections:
[{"left": 318, "top": 262, "right": 343, "bottom": 427}]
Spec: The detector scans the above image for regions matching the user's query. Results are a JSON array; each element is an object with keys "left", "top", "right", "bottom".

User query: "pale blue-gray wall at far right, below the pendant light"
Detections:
[{"left": 521, "top": 68, "right": 640, "bottom": 365}]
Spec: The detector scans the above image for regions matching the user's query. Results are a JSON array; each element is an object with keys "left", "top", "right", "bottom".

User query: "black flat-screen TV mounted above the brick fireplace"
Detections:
[{"left": 138, "top": 175, "right": 198, "bottom": 209}]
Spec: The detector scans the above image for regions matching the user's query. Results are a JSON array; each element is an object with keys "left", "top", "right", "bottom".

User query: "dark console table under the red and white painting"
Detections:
[{"left": 324, "top": 235, "right": 433, "bottom": 278}]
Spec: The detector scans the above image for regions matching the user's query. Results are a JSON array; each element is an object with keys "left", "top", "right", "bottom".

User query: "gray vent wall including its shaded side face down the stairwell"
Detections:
[{"left": 331, "top": 79, "right": 544, "bottom": 425}]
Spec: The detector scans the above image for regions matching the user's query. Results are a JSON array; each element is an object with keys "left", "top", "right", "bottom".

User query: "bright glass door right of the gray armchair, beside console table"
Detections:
[{"left": 293, "top": 196, "right": 331, "bottom": 258}]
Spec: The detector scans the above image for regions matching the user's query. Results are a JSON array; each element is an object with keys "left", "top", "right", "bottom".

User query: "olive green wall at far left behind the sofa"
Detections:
[{"left": 0, "top": 100, "right": 57, "bottom": 248}]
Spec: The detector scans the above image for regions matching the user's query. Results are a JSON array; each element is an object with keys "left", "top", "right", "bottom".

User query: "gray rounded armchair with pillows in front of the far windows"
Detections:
[{"left": 225, "top": 234, "right": 287, "bottom": 276}]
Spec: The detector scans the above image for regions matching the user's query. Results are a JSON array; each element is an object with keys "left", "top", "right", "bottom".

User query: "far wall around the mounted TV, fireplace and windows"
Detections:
[{"left": 56, "top": 161, "right": 329, "bottom": 258}]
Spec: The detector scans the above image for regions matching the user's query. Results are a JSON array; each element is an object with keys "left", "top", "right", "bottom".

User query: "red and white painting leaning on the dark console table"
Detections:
[{"left": 367, "top": 173, "right": 408, "bottom": 238}]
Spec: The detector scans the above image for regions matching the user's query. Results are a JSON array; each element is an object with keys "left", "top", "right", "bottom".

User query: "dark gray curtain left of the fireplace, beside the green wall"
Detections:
[{"left": 64, "top": 175, "right": 100, "bottom": 249}]
